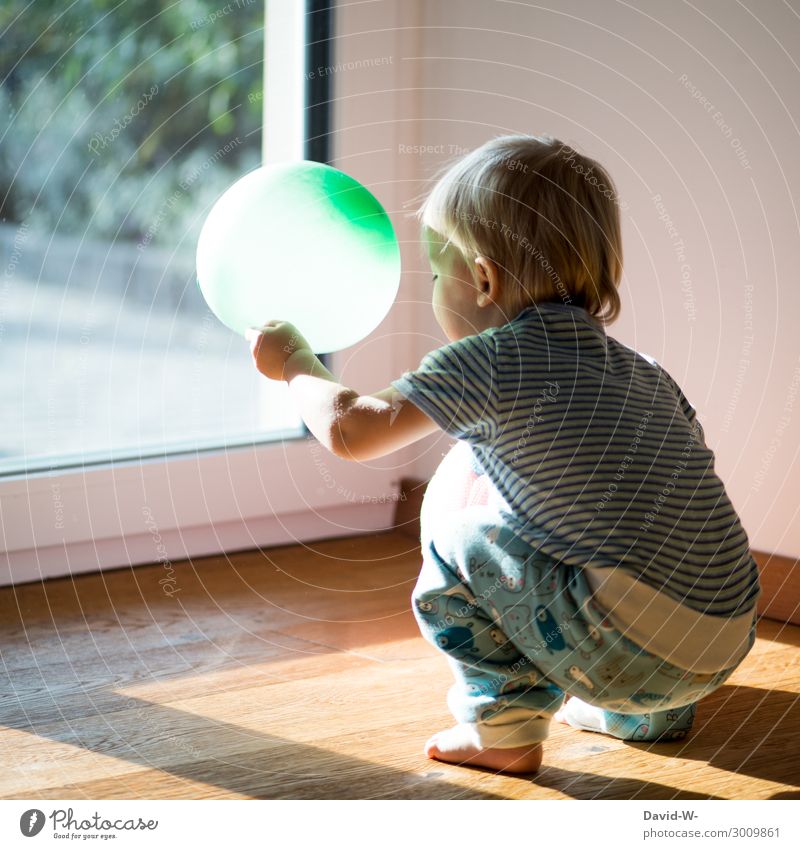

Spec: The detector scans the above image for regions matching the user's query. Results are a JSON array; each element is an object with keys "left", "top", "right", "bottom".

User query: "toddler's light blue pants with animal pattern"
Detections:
[{"left": 412, "top": 443, "right": 755, "bottom": 748}]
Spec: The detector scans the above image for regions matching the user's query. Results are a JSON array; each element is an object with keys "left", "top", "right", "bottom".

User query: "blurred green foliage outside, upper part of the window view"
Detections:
[{"left": 0, "top": 0, "right": 264, "bottom": 247}]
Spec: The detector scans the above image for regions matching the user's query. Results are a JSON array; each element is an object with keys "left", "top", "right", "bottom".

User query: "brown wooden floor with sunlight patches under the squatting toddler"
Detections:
[{"left": 0, "top": 533, "right": 800, "bottom": 799}]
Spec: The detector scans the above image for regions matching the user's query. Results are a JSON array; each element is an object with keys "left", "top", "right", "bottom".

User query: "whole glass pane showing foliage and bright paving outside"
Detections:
[{"left": 0, "top": 0, "right": 302, "bottom": 472}]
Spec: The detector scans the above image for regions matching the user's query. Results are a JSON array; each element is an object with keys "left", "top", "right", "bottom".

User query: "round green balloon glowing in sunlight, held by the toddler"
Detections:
[{"left": 197, "top": 161, "right": 400, "bottom": 354}]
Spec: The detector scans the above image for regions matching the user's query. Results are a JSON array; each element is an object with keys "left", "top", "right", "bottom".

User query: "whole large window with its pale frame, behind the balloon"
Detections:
[{"left": 0, "top": 0, "right": 407, "bottom": 584}]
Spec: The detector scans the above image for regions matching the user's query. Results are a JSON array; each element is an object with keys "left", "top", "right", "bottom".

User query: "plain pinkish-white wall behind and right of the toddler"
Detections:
[{"left": 336, "top": 0, "right": 800, "bottom": 556}]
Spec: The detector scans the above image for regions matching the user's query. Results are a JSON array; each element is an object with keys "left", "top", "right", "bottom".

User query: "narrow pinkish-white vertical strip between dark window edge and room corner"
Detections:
[{"left": 332, "top": 0, "right": 452, "bottom": 490}]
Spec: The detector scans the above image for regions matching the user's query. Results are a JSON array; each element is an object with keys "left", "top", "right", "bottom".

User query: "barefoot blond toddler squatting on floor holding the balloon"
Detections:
[{"left": 249, "top": 135, "right": 760, "bottom": 772}]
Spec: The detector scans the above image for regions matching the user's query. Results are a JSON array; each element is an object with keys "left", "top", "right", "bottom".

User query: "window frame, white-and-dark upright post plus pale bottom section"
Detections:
[{"left": 0, "top": 0, "right": 410, "bottom": 586}]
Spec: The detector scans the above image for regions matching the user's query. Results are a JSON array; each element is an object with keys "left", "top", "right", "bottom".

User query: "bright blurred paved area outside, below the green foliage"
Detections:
[{"left": 0, "top": 276, "right": 302, "bottom": 472}]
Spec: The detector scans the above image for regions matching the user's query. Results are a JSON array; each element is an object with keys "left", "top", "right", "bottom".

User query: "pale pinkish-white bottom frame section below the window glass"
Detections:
[{"left": 0, "top": 438, "right": 406, "bottom": 585}]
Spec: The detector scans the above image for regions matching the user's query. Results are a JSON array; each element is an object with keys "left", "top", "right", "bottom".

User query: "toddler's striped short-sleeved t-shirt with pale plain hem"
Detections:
[{"left": 392, "top": 304, "right": 760, "bottom": 671}]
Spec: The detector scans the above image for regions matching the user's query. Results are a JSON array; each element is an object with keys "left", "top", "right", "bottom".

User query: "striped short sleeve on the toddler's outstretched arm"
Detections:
[{"left": 392, "top": 332, "right": 497, "bottom": 443}]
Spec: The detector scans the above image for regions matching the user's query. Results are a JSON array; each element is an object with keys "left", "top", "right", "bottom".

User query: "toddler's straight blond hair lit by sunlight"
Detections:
[{"left": 417, "top": 135, "right": 622, "bottom": 323}]
